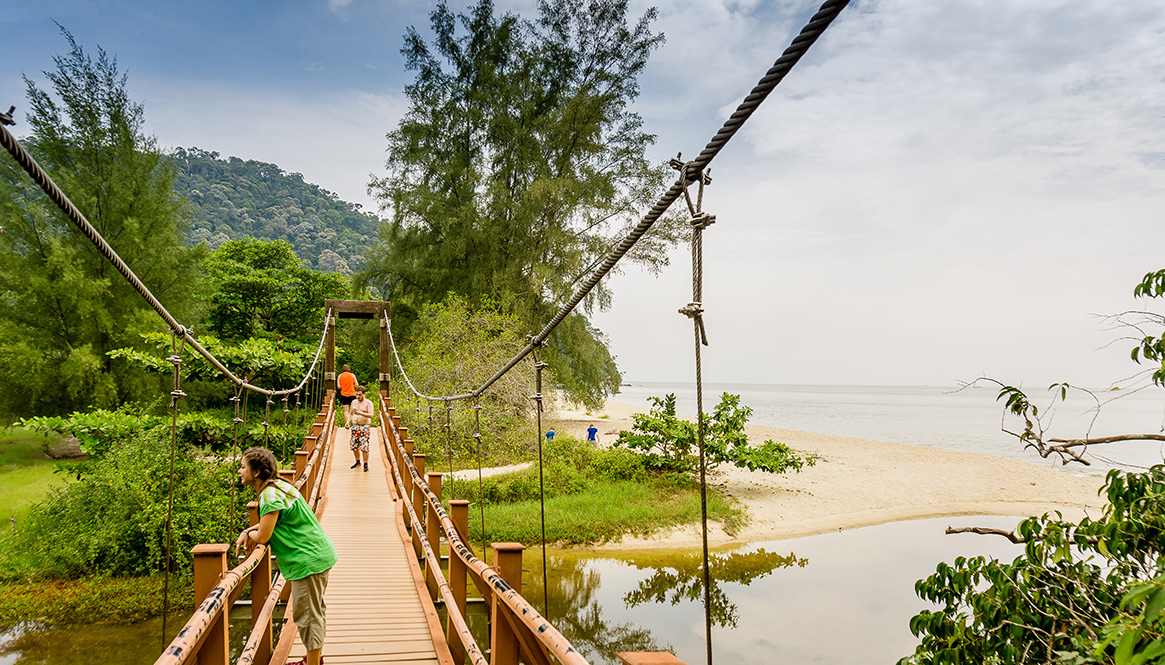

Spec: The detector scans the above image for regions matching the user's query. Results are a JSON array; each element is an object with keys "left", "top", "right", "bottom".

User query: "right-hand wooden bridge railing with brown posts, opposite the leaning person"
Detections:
[{"left": 380, "top": 392, "right": 587, "bottom": 665}]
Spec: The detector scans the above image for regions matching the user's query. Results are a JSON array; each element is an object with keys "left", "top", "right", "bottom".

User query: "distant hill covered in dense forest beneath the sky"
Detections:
[{"left": 171, "top": 148, "right": 377, "bottom": 275}]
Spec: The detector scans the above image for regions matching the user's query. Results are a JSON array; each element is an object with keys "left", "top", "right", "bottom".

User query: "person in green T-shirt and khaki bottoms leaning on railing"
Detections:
[{"left": 234, "top": 448, "right": 338, "bottom": 665}]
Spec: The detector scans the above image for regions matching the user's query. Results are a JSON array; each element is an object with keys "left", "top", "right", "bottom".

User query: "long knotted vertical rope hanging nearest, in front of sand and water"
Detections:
[{"left": 672, "top": 161, "right": 716, "bottom": 665}]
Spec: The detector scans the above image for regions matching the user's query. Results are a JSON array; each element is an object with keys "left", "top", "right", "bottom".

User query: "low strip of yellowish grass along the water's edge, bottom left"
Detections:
[{"left": 0, "top": 575, "right": 195, "bottom": 625}]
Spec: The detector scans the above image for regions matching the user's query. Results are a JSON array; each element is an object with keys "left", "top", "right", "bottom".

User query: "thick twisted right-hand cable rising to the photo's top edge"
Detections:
[{"left": 377, "top": 0, "right": 849, "bottom": 399}]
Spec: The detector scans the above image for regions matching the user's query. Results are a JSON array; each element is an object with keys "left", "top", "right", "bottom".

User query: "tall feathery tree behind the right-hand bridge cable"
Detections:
[{"left": 360, "top": 0, "right": 678, "bottom": 404}]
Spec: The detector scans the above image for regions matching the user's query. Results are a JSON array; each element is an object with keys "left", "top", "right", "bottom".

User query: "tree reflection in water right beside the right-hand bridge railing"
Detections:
[{"left": 531, "top": 557, "right": 661, "bottom": 663}]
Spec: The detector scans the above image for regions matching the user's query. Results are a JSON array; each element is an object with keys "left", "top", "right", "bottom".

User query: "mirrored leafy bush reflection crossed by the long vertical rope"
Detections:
[{"left": 623, "top": 549, "right": 809, "bottom": 628}]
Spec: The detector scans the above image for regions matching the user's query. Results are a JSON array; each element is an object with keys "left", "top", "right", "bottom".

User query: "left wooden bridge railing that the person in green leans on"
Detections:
[{"left": 154, "top": 390, "right": 336, "bottom": 665}]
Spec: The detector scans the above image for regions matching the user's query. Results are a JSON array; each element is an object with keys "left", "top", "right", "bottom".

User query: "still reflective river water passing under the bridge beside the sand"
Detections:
[{"left": 0, "top": 516, "right": 1022, "bottom": 665}]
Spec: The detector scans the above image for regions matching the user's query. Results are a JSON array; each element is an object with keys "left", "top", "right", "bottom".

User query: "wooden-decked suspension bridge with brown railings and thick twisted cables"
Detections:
[{"left": 0, "top": 0, "right": 848, "bottom": 665}]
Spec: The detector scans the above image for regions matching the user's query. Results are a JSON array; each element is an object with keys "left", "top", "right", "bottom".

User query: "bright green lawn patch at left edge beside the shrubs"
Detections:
[{"left": 0, "top": 427, "right": 64, "bottom": 531}]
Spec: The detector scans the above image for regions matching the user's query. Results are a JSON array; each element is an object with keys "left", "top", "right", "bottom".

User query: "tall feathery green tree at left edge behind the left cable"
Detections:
[{"left": 0, "top": 29, "right": 200, "bottom": 417}]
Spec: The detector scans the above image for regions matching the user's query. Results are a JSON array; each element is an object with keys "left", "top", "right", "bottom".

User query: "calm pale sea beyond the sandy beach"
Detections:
[{"left": 613, "top": 381, "right": 1165, "bottom": 473}]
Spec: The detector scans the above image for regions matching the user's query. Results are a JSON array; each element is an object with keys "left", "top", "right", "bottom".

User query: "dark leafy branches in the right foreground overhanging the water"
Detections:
[{"left": 899, "top": 270, "right": 1165, "bottom": 665}]
